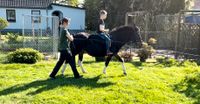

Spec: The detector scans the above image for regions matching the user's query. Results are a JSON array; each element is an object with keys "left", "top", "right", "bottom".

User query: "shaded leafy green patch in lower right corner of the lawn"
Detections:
[{"left": 174, "top": 72, "right": 200, "bottom": 104}]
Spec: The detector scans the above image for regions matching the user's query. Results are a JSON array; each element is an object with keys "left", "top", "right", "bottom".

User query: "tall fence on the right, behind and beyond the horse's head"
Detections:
[{"left": 126, "top": 11, "right": 200, "bottom": 57}]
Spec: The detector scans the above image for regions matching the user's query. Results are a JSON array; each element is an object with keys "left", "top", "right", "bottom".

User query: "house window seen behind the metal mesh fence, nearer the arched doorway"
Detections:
[{"left": 31, "top": 10, "right": 41, "bottom": 23}]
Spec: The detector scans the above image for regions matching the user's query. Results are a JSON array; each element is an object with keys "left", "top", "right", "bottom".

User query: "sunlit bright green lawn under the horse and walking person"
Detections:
[{"left": 0, "top": 56, "right": 200, "bottom": 104}]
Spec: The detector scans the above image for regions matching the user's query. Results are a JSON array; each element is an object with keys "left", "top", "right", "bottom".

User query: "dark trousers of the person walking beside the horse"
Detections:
[{"left": 50, "top": 50, "right": 80, "bottom": 78}]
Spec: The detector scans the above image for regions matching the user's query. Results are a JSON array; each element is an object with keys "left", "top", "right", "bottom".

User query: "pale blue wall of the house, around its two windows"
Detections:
[{"left": 0, "top": 5, "right": 85, "bottom": 31}]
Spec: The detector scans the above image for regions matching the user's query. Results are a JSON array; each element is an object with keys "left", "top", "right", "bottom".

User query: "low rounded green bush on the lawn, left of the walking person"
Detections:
[{"left": 7, "top": 48, "right": 44, "bottom": 64}]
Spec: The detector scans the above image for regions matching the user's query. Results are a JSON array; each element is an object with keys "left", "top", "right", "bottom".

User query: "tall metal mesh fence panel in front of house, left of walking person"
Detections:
[{"left": 22, "top": 15, "right": 59, "bottom": 56}]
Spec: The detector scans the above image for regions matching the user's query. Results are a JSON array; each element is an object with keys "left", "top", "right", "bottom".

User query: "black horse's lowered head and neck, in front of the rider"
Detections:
[{"left": 110, "top": 26, "right": 142, "bottom": 47}]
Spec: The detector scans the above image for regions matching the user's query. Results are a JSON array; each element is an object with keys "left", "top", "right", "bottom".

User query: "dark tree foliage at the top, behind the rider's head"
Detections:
[{"left": 85, "top": 0, "right": 188, "bottom": 30}]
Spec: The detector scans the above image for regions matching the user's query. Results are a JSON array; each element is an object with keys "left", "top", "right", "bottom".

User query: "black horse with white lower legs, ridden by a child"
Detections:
[{"left": 62, "top": 26, "right": 142, "bottom": 75}]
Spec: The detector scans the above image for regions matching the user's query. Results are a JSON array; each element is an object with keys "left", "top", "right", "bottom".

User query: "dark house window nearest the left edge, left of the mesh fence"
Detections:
[{"left": 6, "top": 10, "right": 16, "bottom": 22}]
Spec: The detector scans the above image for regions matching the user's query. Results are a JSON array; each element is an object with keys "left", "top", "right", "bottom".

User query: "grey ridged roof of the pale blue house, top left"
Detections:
[{"left": 0, "top": 0, "right": 53, "bottom": 9}]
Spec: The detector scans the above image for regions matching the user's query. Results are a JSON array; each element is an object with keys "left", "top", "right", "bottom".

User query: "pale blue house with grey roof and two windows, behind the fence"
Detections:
[{"left": 0, "top": 0, "right": 85, "bottom": 32}]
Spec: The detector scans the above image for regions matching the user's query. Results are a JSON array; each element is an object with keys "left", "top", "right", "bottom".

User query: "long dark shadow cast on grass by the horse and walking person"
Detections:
[{"left": 0, "top": 75, "right": 114, "bottom": 96}]
